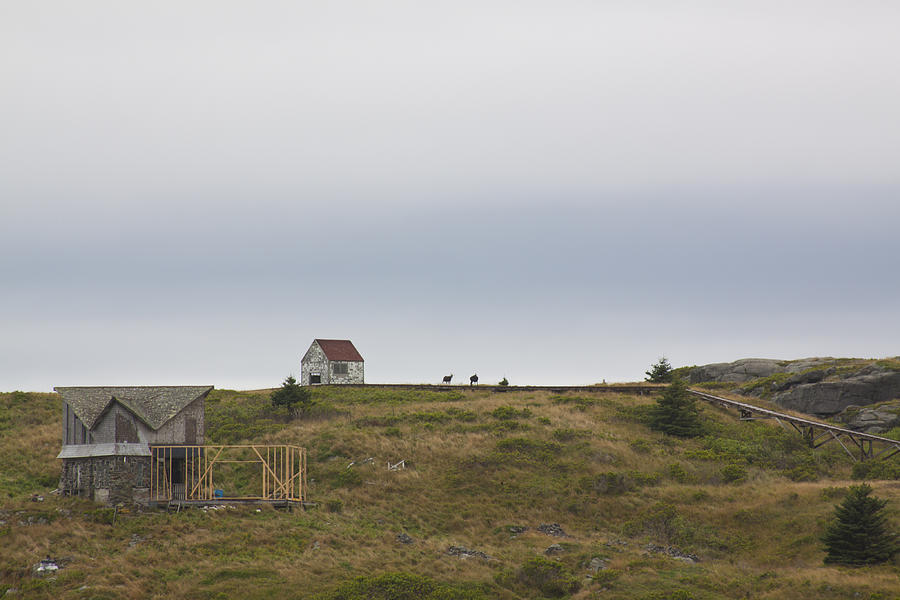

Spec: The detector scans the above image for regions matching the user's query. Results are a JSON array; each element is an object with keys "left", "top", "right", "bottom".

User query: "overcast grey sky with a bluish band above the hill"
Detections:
[{"left": 0, "top": 0, "right": 900, "bottom": 391}]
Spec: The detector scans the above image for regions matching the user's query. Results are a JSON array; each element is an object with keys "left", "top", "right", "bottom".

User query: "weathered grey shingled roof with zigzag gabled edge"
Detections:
[{"left": 53, "top": 385, "right": 213, "bottom": 431}]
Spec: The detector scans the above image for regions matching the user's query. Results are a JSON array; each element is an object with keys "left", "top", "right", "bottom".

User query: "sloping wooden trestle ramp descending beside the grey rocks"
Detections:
[{"left": 688, "top": 390, "right": 900, "bottom": 461}]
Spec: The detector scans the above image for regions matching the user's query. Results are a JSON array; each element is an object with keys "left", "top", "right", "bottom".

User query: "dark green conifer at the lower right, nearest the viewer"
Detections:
[{"left": 822, "top": 483, "right": 900, "bottom": 565}]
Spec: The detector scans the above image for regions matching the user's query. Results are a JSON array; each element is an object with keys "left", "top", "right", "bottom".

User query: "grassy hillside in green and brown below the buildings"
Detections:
[{"left": 0, "top": 387, "right": 900, "bottom": 599}]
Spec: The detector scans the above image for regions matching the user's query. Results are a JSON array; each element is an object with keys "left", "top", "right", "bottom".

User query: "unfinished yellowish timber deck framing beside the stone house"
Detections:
[{"left": 150, "top": 445, "right": 306, "bottom": 506}]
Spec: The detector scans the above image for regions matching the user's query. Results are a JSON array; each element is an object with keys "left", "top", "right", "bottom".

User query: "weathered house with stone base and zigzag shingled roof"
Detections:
[{"left": 54, "top": 386, "right": 213, "bottom": 504}]
